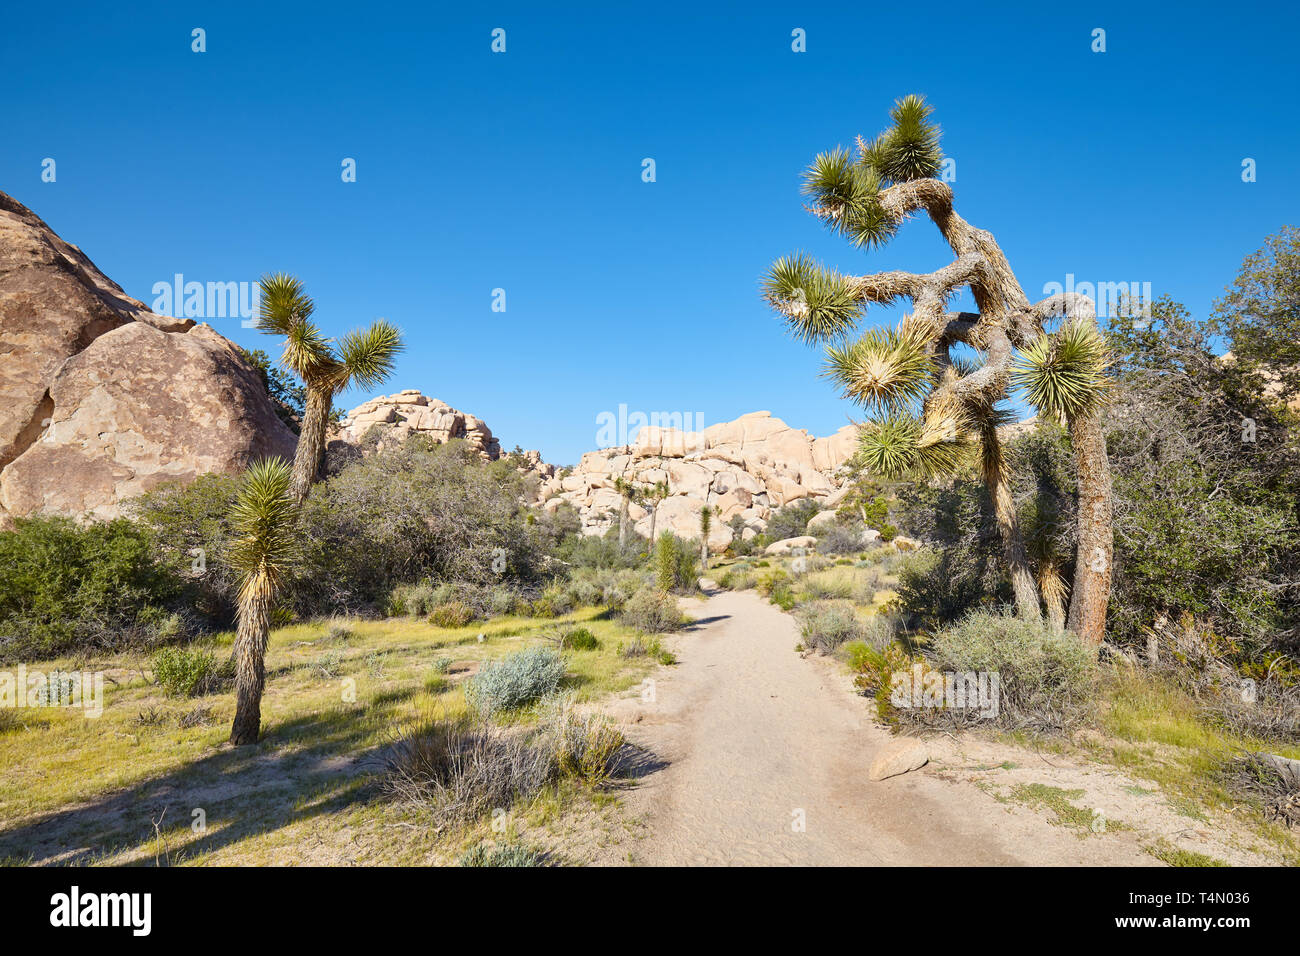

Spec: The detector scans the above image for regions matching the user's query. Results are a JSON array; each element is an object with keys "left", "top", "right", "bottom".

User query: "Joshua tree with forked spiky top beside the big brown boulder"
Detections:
[{"left": 257, "top": 272, "right": 403, "bottom": 503}]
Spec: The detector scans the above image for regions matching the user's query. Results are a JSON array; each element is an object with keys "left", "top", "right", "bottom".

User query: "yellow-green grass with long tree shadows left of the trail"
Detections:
[{"left": 0, "top": 609, "right": 655, "bottom": 865}]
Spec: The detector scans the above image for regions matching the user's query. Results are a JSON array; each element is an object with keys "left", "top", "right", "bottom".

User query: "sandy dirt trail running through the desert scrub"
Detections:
[{"left": 595, "top": 582, "right": 1154, "bottom": 865}]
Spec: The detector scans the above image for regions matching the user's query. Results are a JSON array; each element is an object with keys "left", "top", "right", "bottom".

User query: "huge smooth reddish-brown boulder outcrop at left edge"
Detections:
[{"left": 0, "top": 193, "right": 295, "bottom": 524}]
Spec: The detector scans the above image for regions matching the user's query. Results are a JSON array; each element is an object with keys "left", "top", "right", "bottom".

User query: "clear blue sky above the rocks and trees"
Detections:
[{"left": 0, "top": 0, "right": 1300, "bottom": 463}]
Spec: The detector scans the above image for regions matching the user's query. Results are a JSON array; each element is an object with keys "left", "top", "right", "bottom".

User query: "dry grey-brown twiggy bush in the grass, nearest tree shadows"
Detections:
[{"left": 381, "top": 717, "right": 558, "bottom": 823}]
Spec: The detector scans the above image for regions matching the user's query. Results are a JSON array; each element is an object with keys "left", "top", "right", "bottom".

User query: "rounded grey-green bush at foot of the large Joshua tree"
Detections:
[{"left": 909, "top": 611, "right": 1099, "bottom": 731}]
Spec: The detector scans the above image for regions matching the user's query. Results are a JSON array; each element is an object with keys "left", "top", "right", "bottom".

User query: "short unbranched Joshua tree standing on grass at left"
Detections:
[{"left": 230, "top": 458, "right": 298, "bottom": 745}]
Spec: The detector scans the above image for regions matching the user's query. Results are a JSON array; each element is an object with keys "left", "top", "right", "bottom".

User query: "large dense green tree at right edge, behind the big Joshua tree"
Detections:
[{"left": 1106, "top": 298, "right": 1300, "bottom": 676}]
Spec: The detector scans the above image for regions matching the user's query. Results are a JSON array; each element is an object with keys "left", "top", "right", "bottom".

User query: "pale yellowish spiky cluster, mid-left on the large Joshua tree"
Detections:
[{"left": 823, "top": 329, "right": 935, "bottom": 411}]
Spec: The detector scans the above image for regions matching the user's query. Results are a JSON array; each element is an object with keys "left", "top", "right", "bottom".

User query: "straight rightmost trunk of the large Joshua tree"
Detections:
[{"left": 1069, "top": 412, "right": 1114, "bottom": 644}]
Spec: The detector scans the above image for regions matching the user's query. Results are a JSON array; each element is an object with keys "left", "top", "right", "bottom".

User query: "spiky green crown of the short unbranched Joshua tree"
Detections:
[{"left": 229, "top": 458, "right": 298, "bottom": 596}]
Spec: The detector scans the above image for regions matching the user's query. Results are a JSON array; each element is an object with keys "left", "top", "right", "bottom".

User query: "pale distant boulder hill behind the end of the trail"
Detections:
[{"left": 538, "top": 411, "right": 857, "bottom": 550}]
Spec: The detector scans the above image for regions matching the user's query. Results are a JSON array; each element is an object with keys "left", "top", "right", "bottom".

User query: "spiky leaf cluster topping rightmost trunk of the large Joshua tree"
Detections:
[{"left": 1013, "top": 321, "right": 1110, "bottom": 421}]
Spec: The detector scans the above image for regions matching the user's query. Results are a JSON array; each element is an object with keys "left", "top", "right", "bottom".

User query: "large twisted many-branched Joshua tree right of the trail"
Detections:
[{"left": 764, "top": 96, "right": 1110, "bottom": 641}]
